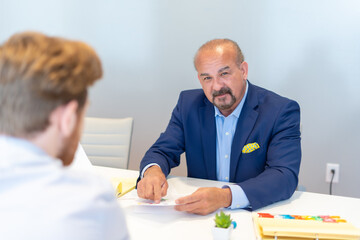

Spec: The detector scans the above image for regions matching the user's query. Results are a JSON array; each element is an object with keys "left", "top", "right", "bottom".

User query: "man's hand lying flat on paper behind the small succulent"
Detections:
[{"left": 175, "top": 187, "right": 232, "bottom": 215}]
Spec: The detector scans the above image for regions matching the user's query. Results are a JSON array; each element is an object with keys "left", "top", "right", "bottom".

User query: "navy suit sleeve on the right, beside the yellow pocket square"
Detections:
[{"left": 239, "top": 101, "right": 301, "bottom": 210}]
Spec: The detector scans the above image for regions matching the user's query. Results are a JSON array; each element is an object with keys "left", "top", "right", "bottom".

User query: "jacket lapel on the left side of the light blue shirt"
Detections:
[{"left": 199, "top": 99, "right": 217, "bottom": 180}]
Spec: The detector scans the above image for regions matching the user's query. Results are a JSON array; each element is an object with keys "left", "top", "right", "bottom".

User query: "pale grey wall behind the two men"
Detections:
[{"left": 0, "top": 0, "right": 360, "bottom": 197}]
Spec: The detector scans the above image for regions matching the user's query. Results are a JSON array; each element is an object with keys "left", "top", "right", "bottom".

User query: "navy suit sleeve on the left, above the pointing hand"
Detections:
[{"left": 140, "top": 94, "right": 185, "bottom": 176}]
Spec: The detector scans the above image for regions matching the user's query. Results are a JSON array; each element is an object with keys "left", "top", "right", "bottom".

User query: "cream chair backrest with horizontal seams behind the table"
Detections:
[{"left": 80, "top": 117, "right": 134, "bottom": 169}]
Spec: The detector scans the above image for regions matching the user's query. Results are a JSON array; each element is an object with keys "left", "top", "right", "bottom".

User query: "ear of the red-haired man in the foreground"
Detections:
[{"left": 60, "top": 100, "right": 79, "bottom": 137}]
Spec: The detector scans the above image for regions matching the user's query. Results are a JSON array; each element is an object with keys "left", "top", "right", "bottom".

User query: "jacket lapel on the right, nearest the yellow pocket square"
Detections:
[{"left": 230, "top": 83, "right": 258, "bottom": 182}]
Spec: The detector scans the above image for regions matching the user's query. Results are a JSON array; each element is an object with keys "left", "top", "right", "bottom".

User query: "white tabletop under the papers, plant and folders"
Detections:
[{"left": 95, "top": 167, "right": 360, "bottom": 240}]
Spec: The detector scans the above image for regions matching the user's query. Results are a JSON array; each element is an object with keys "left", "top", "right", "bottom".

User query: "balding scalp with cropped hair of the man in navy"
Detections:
[{"left": 194, "top": 39, "right": 244, "bottom": 70}]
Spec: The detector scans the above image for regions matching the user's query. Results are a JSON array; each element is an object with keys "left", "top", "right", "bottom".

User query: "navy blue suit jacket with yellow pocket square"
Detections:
[{"left": 140, "top": 83, "right": 301, "bottom": 210}]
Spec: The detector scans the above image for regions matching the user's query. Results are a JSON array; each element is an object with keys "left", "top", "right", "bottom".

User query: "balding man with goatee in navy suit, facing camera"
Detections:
[{"left": 137, "top": 39, "right": 301, "bottom": 215}]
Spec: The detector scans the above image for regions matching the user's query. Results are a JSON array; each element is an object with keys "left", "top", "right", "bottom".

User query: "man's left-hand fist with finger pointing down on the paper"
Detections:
[{"left": 137, "top": 165, "right": 168, "bottom": 203}]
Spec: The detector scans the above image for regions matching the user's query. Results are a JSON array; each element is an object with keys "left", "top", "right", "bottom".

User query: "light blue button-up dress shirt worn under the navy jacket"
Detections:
[{"left": 214, "top": 82, "right": 249, "bottom": 209}]
